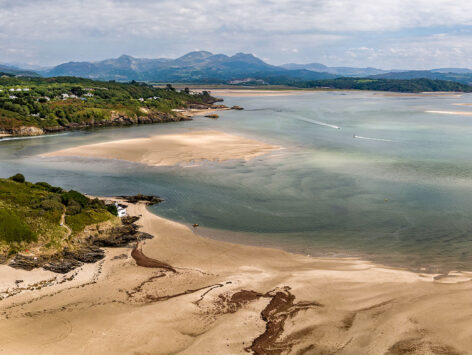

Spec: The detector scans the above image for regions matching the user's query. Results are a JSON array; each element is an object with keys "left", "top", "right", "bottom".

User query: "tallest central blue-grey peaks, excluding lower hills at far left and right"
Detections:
[{"left": 40, "top": 51, "right": 333, "bottom": 82}]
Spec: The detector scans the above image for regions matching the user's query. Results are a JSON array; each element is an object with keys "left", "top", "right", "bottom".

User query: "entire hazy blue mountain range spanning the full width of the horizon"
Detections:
[{"left": 0, "top": 51, "right": 472, "bottom": 85}]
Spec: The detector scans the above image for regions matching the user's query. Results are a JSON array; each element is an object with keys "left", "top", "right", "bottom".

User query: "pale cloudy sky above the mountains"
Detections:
[{"left": 0, "top": 0, "right": 472, "bottom": 69}]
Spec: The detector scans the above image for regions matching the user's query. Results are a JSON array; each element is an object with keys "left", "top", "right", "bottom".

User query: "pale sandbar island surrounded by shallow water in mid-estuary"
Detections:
[{"left": 42, "top": 131, "right": 279, "bottom": 166}]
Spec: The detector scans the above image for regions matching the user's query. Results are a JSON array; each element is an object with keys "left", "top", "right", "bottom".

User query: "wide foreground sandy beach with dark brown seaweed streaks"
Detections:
[{"left": 0, "top": 204, "right": 472, "bottom": 354}]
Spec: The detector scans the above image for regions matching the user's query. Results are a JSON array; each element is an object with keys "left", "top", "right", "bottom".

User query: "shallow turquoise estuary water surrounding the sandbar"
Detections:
[{"left": 0, "top": 92, "right": 472, "bottom": 271}]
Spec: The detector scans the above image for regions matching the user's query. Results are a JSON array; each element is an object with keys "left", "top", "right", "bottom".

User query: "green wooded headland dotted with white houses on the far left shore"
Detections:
[{"left": 0, "top": 77, "right": 215, "bottom": 132}]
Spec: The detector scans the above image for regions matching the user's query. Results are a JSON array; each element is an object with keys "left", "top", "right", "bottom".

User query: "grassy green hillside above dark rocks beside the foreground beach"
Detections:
[{"left": 0, "top": 174, "right": 114, "bottom": 254}]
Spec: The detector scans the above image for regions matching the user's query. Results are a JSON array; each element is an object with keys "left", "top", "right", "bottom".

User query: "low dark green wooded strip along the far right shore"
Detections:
[{"left": 287, "top": 78, "right": 472, "bottom": 92}]
